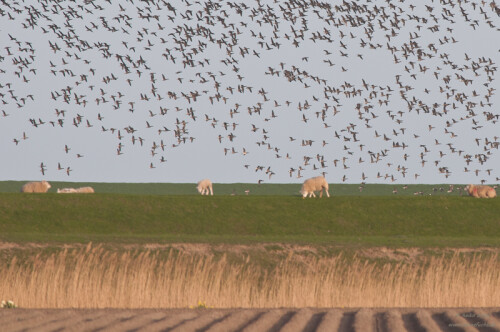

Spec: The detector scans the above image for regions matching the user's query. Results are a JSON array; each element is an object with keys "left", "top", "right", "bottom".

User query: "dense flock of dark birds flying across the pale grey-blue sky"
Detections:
[{"left": 0, "top": 0, "right": 500, "bottom": 183}]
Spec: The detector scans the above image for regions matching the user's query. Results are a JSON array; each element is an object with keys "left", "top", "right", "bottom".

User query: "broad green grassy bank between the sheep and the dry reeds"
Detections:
[{"left": 0, "top": 194, "right": 500, "bottom": 247}]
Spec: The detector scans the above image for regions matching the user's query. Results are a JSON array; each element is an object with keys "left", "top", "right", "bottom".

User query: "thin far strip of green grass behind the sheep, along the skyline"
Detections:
[{"left": 0, "top": 181, "right": 488, "bottom": 196}]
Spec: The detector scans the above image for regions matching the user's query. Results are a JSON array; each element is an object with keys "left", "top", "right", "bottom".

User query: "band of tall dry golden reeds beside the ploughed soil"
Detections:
[{"left": 0, "top": 245, "right": 500, "bottom": 308}]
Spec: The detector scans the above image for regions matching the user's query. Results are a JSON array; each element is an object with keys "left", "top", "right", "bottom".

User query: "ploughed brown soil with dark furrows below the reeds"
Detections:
[{"left": 0, "top": 308, "right": 500, "bottom": 332}]
